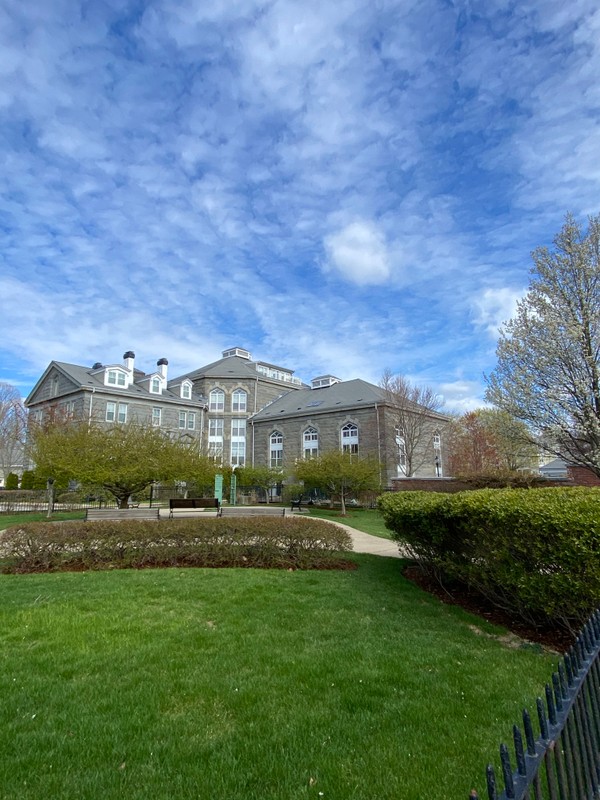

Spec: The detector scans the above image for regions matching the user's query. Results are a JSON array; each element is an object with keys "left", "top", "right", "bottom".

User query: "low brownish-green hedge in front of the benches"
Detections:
[{"left": 0, "top": 518, "right": 352, "bottom": 573}]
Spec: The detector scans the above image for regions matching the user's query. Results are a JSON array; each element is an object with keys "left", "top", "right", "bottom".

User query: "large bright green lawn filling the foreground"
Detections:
[{"left": 0, "top": 555, "right": 551, "bottom": 800}]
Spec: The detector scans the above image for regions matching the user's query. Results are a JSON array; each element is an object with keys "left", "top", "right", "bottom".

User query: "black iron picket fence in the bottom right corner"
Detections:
[{"left": 470, "top": 611, "right": 600, "bottom": 800}]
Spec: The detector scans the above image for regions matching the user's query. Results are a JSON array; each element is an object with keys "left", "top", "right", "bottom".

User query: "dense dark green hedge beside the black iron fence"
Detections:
[{"left": 379, "top": 487, "right": 600, "bottom": 631}]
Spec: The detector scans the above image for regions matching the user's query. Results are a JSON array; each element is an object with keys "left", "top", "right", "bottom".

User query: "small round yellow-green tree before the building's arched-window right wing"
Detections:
[{"left": 294, "top": 450, "right": 381, "bottom": 515}]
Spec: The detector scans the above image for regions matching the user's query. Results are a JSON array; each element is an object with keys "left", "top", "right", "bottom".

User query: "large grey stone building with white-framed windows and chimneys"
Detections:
[{"left": 25, "top": 347, "right": 447, "bottom": 483}]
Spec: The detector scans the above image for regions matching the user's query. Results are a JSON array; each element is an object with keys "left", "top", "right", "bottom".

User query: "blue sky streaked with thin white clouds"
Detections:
[{"left": 0, "top": 0, "right": 600, "bottom": 412}]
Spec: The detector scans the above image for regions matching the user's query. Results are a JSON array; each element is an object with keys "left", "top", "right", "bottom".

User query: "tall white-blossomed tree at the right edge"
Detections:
[{"left": 486, "top": 215, "right": 600, "bottom": 477}]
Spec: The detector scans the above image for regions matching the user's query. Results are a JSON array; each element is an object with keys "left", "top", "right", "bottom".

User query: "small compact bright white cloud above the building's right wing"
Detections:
[{"left": 324, "top": 220, "right": 391, "bottom": 286}]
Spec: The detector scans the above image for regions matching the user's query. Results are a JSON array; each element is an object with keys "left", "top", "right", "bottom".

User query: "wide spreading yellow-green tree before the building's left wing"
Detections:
[{"left": 31, "top": 422, "right": 214, "bottom": 508}]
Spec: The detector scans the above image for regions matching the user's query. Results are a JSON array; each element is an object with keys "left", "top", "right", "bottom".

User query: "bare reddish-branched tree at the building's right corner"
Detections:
[{"left": 379, "top": 369, "right": 446, "bottom": 478}]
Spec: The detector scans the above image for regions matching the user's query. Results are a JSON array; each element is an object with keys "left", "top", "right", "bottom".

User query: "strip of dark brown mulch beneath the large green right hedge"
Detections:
[{"left": 403, "top": 565, "right": 574, "bottom": 653}]
